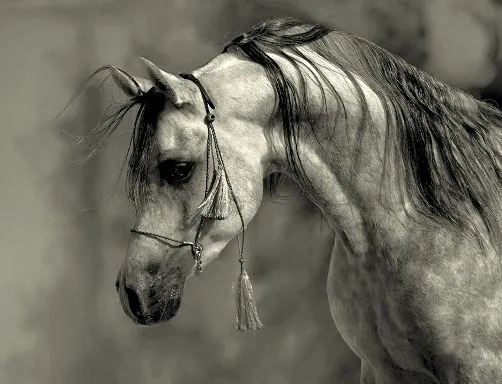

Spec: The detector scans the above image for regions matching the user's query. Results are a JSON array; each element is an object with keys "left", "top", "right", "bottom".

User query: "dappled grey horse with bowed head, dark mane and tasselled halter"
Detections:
[{"left": 79, "top": 18, "right": 502, "bottom": 384}]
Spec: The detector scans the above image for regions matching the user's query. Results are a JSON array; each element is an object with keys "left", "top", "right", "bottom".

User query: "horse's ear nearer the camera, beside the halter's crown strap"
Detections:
[{"left": 140, "top": 57, "right": 194, "bottom": 107}]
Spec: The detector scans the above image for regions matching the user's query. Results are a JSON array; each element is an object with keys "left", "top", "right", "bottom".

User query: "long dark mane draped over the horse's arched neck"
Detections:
[{"left": 224, "top": 18, "right": 502, "bottom": 254}]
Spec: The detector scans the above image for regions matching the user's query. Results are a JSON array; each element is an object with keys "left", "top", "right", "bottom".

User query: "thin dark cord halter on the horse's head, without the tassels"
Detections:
[{"left": 130, "top": 73, "right": 244, "bottom": 275}]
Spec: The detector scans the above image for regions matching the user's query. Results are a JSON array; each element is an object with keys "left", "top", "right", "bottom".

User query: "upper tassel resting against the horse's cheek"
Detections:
[{"left": 198, "top": 165, "right": 230, "bottom": 220}]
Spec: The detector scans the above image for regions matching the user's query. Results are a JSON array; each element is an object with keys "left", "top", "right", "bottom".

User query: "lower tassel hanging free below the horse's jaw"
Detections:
[{"left": 235, "top": 259, "right": 263, "bottom": 331}]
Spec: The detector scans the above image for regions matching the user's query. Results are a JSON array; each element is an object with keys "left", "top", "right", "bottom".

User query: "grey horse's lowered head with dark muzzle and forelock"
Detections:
[{"left": 111, "top": 55, "right": 273, "bottom": 325}]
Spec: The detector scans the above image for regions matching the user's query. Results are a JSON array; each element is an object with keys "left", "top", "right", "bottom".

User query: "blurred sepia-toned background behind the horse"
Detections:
[{"left": 0, "top": 0, "right": 502, "bottom": 384}]
